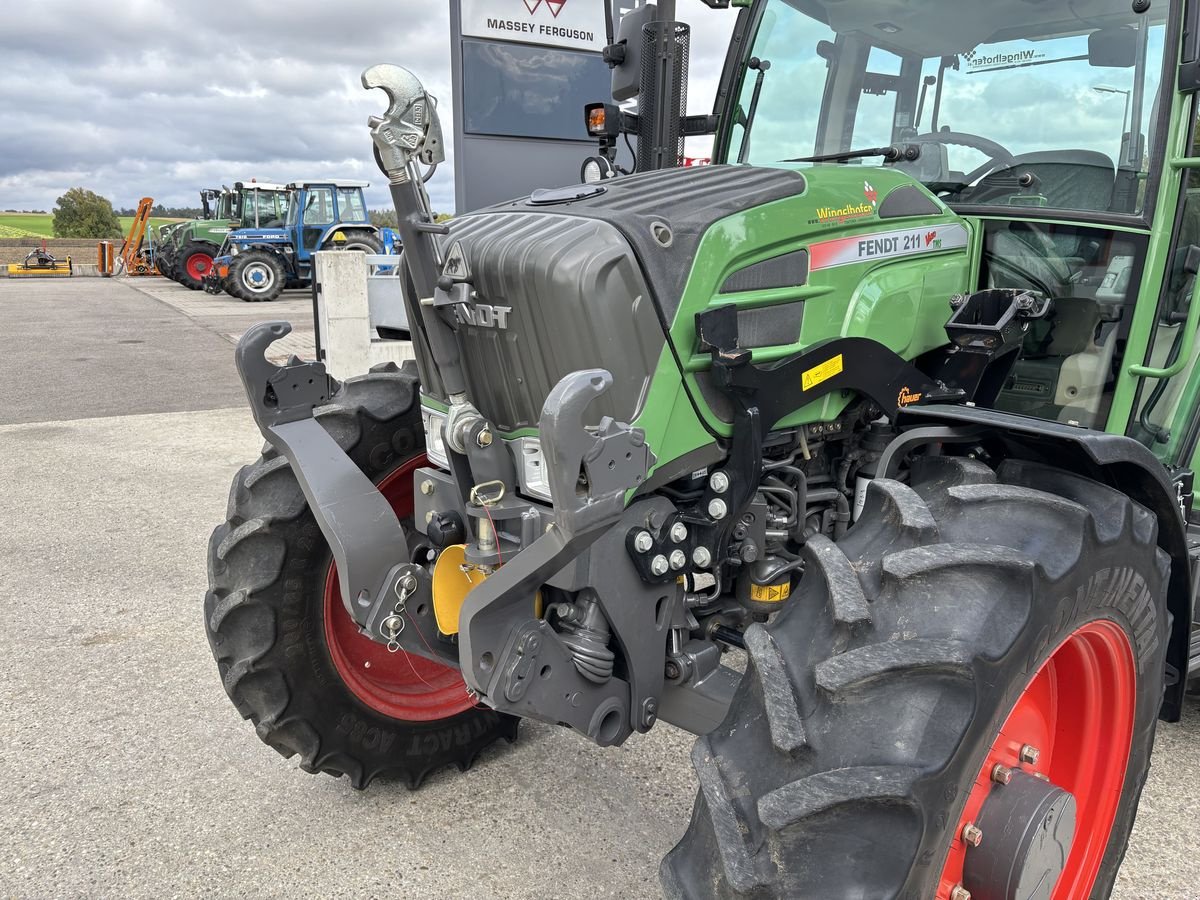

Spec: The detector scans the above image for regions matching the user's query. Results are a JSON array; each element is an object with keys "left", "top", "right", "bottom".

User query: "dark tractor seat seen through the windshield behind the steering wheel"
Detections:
[{"left": 972, "top": 150, "right": 1116, "bottom": 211}]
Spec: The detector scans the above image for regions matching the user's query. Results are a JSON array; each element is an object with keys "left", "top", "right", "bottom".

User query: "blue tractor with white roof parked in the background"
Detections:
[{"left": 204, "top": 181, "right": 392, "bottom": 302}]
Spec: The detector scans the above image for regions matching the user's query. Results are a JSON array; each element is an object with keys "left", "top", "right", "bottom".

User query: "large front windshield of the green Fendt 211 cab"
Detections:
[{"left": 725, "top": 0, "right": 1170, "bottom": 215}]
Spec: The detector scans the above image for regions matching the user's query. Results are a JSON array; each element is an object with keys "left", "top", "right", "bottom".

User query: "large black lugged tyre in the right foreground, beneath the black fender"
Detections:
[{"left": 661, "top": 457, "right": 1170, "bottom": 899}]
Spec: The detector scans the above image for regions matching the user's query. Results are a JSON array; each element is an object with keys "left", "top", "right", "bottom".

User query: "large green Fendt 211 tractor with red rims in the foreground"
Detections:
[{"left": 204, "top": 0, "right": 1200, "bottom": 900}]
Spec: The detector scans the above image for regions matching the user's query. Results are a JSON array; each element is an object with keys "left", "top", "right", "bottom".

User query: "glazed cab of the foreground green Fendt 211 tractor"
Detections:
[{"left": 715, "top": 0, "right": 1200, "bottom": 464}]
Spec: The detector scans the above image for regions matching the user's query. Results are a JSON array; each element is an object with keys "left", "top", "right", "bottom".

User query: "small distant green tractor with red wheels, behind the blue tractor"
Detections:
[{"left": 160, "top": 181, "right": 289, "bottom": 290}]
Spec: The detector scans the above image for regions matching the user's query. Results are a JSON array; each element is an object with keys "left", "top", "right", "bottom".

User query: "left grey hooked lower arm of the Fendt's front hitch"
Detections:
[{"left": 234, "top": 322, "right": 429, "bottom": 661}]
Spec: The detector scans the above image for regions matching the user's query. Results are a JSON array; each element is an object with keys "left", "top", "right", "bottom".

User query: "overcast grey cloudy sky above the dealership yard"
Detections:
[{"left": 0, "top": 0, "right": 734, "bottom": 217}]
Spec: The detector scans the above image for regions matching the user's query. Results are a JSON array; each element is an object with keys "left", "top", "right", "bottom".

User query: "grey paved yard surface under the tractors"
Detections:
[{"left": 0, "top": 280, "right": 1200, "bottom": 900}]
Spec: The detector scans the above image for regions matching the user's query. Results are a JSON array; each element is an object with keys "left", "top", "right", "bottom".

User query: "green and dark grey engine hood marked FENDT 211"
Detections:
[{"left": 425, "top": 166, "right": 968, "bottom": 433}]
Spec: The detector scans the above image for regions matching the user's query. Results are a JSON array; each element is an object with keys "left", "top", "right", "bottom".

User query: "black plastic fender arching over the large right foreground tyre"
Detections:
[{"left": 884, "top": 404, "right": 1194, "bottom": 722}]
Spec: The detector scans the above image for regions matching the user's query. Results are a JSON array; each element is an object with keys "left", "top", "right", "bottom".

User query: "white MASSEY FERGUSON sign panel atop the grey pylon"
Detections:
[{"left": 462, "top": 0, "right": 608, "bottom": 50}]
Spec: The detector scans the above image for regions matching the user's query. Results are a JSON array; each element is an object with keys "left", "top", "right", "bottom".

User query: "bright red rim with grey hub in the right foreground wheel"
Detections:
[{"left": 937, "top": 620, "right": 1138, "bottom": 900}]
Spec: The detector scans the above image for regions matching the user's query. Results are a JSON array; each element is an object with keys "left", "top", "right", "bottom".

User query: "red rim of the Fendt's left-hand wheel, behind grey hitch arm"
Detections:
[{"left": 324, "top": 454, "right": 475, "bottom": 722}]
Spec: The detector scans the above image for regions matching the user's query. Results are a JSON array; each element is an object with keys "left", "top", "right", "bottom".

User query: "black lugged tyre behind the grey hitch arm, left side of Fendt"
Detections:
[{"left": 204, "top": 365, "right": 517, "bottom": 788}]
